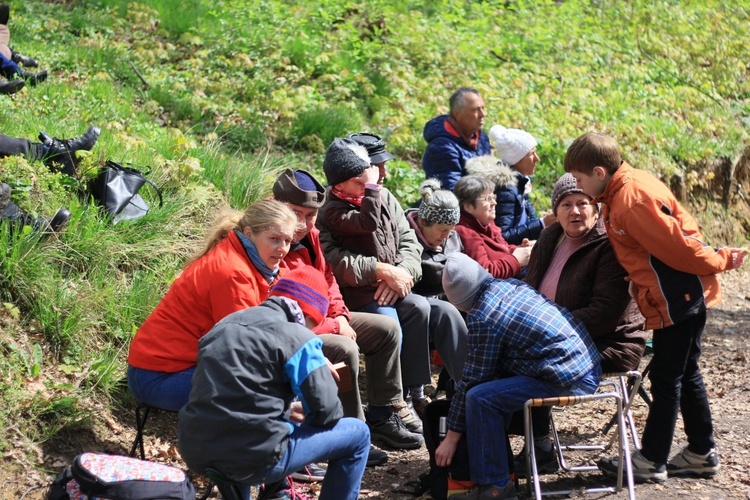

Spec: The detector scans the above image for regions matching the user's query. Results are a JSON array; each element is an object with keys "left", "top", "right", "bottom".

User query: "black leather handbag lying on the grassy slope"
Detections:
[{"left": 90, "top": 161, "right": 163, "bottom": 223}]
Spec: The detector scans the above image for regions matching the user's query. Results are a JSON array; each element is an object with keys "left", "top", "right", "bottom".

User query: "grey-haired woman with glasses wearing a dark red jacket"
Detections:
[{"left": 453, "top": 175, "right": 531, "bottom": 279}]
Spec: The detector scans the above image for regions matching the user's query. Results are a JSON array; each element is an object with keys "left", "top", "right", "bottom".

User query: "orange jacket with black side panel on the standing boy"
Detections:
[{"left": 594, "top": 162, "right": 731, "bottom": 329}]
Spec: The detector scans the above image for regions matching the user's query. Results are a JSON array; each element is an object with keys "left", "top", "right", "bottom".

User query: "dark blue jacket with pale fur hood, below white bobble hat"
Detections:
[{"left": 466, "top": 156, "right": 544, "bottom": 245}]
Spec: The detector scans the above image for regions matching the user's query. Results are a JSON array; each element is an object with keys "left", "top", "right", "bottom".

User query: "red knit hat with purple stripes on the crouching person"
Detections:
[{"left": 268, "top": 266, "right": 329, "bottom": 326}]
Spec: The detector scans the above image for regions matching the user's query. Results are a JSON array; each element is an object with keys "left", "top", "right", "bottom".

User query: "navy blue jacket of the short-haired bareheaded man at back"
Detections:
[{"left": 422, "top": 115, "right": 490, "bottom": 191}]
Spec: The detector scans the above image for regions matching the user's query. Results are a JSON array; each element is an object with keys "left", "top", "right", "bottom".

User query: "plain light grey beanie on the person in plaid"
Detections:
[{"left": 443, "top": 252, "right": 492, "bottom": 312}]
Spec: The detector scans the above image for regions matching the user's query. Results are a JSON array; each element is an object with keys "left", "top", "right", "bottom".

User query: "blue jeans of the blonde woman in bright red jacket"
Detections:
[{"left": 128, "top": 365, "right": 195, "bottom": 411}]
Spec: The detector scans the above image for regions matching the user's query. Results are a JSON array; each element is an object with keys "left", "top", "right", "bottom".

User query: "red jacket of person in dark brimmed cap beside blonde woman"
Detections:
[{"left": 281, "top": 227, "right": 349, "bottom": 334}]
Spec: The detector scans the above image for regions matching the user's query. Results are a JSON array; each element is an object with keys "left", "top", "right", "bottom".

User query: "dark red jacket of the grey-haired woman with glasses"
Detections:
[{"left": 456, "top": 210, "right": 521, "bottom": 279}]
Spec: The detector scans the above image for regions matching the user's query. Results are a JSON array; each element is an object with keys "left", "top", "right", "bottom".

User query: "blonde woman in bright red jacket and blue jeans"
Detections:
[{"left": 128, "top": 200, "right": 297, "bottom": 411}]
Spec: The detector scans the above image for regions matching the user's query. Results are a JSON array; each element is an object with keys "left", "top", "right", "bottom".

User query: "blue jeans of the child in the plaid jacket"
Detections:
[{"left": 466, "top": 366, "right": 601, "bottom": 485}]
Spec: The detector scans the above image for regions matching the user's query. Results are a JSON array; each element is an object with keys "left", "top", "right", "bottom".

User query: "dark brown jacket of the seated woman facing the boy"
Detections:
[{"left": 525, "top": 218, "right": 647, "bottom": 371}]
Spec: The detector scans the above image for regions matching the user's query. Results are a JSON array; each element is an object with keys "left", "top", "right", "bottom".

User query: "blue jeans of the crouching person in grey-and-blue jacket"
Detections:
[{"left": 243, "top": 418, "right": 370, "bottom": 500}]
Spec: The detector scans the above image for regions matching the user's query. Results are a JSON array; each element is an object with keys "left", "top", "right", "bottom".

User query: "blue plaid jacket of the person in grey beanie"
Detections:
[{"left": 448, "top": 279, "right": 599, "bottom": 433}]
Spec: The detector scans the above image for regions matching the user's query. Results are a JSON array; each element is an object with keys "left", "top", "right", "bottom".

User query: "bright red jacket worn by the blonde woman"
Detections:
[{"left": 128, "top": 231, "right": 286, "bottom": 373}]
